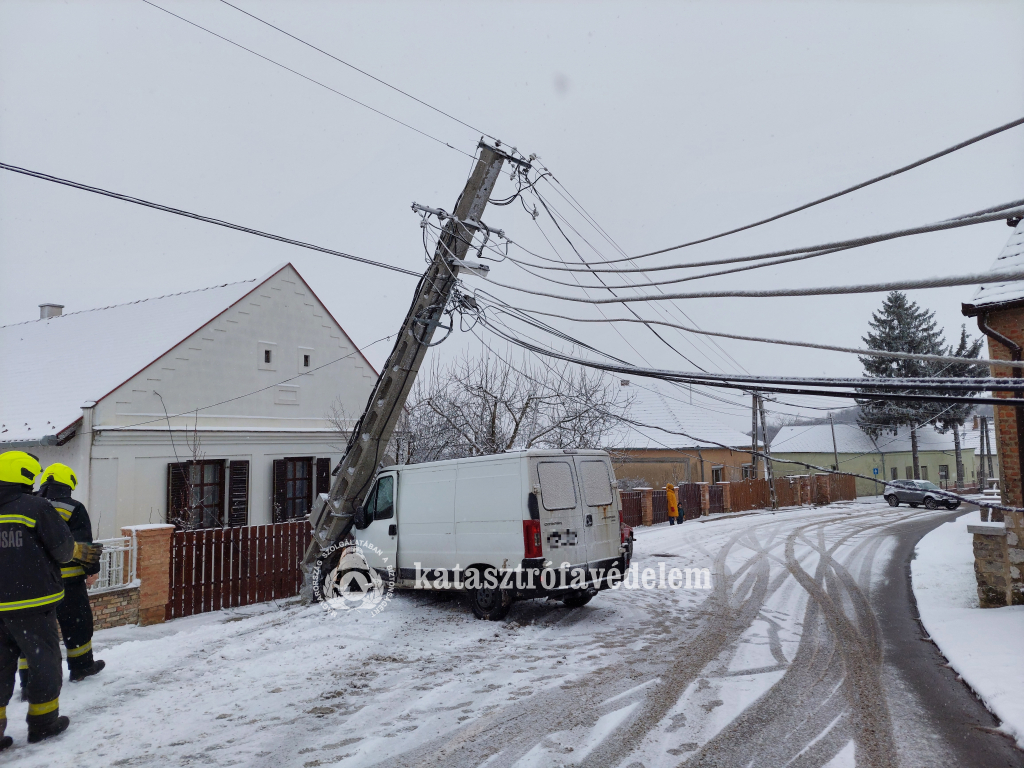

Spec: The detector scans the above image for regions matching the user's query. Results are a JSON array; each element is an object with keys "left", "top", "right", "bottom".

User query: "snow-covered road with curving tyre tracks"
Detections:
[{"left": 4, "top": 501, "right": 1020, "bottom": 768}]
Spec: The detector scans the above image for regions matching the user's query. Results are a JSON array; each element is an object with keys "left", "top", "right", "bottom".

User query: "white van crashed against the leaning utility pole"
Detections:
[{"left": 313, "top": 450, "right": 632, "bottom": 620}]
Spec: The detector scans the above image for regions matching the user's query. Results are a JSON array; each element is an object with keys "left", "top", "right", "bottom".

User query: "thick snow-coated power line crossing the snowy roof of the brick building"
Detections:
[{"left": 490, "top": 268, "right": 1024, "bottom": 304}]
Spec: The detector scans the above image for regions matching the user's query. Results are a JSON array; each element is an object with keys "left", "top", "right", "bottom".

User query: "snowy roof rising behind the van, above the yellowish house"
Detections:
[{"left": 605, "top": 379, "right": 751, "bottom": 451}]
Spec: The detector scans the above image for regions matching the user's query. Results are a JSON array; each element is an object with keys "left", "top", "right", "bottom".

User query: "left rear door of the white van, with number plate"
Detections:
[{"left": 534, "top": 456, "right": 588, "bottom": 568}]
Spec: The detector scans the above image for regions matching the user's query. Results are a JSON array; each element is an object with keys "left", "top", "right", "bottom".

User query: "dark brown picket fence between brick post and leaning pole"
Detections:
[{"left": 166, "top": 520, "right": 311, "bottom": 618}]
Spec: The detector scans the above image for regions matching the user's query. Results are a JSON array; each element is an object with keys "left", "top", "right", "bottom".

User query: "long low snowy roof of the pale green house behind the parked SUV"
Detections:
[{"left": 771, "top": 424, "right": 967, "bottom": 455}]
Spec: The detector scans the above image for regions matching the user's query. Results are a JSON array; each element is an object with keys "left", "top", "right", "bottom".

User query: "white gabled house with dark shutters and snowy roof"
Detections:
[{"left": 0, "top": 264, "right": 377, "bottom": 537}]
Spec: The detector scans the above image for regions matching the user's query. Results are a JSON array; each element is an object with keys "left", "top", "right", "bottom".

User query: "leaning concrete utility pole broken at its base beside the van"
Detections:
[{"left": 302, "top": 143, "right": 512, "bottom": 599}]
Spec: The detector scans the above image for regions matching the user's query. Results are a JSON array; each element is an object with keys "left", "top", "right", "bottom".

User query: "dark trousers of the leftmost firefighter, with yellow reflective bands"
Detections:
[{"left": 0, "top": 608, "right": 63, "bottom": 726}]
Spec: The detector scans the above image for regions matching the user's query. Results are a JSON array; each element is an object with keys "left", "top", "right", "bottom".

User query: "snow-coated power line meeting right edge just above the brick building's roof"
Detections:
[{"left": 510, "top": 199, "right": 1024, "bottom": 274}]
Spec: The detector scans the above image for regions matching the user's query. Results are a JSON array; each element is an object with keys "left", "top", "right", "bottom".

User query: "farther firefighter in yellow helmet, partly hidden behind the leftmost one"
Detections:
[{"left": 33, "top": 464, "right": 105, "bottom": 685}]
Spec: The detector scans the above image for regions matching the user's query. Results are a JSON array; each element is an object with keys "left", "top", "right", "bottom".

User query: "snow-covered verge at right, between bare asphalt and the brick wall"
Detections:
[{"left": 910, "top": 512, "right": 1024, "bottom": 748}]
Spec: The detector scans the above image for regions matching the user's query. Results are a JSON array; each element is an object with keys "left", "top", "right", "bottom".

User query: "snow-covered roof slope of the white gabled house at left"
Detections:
[{"left": 0, "top": 264, "right": 373, "bottom": 450}]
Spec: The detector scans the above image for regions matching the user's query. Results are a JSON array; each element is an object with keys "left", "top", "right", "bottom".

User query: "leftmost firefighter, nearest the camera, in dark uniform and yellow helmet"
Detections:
[{"left": 0, "top": 451, "right": 100, "bottom": 750}]
